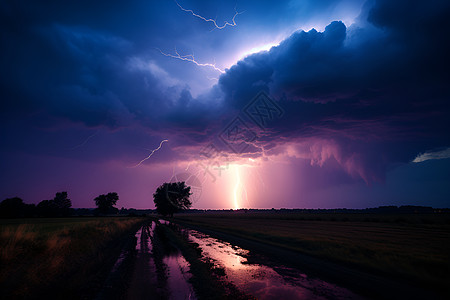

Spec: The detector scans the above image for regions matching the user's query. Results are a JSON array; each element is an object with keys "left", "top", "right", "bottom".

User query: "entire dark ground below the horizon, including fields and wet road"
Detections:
[{"left": 0, "top": 211, "right": 450, "bottom": 299}]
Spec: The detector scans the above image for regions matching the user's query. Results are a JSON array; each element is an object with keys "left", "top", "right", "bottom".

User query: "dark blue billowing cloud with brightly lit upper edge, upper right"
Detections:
[{"left": 219, "top": 1, "right": 450, "bottom": 102}]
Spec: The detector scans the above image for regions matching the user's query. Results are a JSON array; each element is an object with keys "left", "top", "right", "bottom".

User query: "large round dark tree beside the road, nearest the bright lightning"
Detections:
[{"left": 153, "top": 181, "right": 192, "bottom": 216}]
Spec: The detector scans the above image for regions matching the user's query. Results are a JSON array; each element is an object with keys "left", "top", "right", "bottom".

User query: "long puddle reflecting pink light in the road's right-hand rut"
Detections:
[{"left": 186, "top": 229, "right": 360, "bottom": 299}]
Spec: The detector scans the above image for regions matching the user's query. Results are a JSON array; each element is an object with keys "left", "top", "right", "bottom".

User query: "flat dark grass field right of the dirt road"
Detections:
[{"left": 176, "top": 212, "right": 450, "bottom": 290}]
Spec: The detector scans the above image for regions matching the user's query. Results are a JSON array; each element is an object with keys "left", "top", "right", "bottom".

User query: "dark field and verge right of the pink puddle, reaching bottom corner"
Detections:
[{"left": 175, "top": 211, "right": 450, "bottom": 298}]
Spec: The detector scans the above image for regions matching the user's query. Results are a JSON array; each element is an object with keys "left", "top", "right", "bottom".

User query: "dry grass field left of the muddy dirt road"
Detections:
[{"left": 0, "top": 217, "right": 142, "bottom": 298}]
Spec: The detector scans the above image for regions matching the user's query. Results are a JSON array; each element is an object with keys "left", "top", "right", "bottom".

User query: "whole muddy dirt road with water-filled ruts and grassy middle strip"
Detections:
[{"left": 98, "top": 220, "right": 384, "bottom": 299}]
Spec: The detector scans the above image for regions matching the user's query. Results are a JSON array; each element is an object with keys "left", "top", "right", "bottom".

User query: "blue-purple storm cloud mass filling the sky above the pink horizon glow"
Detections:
[{"left": 0, "top": 0, "right": 450, "bottom": 206}]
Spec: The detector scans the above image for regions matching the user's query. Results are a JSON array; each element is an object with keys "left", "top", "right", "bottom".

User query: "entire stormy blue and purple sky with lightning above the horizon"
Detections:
[{"left": 0, "top": 0, "right": 450, "bottom": 208}]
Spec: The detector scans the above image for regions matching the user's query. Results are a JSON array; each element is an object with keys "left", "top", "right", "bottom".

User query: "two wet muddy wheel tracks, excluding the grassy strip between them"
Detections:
[{"left": 99, "top": 220, "right": 360, "bottom": 299}]
